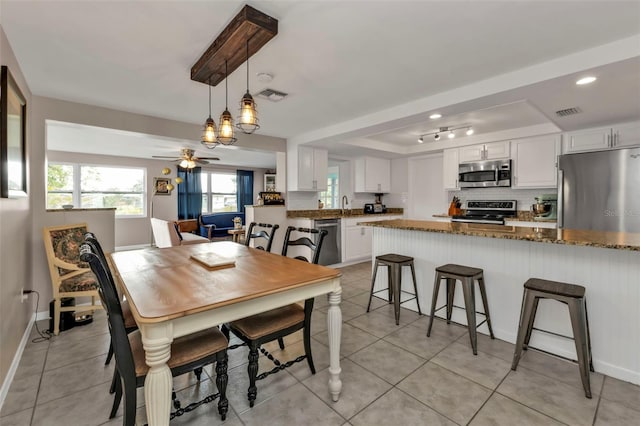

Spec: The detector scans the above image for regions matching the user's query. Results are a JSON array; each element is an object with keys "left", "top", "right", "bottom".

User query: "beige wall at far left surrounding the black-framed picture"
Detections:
[{"left": 0, "top": 26, "right": 34, "bottom": 392}]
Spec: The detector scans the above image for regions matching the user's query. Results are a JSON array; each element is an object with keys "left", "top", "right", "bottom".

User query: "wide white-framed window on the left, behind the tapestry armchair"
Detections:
[{"left": 47, "top": 163, "right": 146, "bottom": 217}]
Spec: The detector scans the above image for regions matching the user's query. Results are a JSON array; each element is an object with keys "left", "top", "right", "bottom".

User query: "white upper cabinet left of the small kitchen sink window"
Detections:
[{"left": 287, "top": 146, "right": 328, "bottom": 191}]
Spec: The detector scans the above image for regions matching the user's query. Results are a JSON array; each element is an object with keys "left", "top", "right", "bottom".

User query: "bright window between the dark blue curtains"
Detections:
[{"left": 200, "top": 172, "right": 238, "bottom": 213}]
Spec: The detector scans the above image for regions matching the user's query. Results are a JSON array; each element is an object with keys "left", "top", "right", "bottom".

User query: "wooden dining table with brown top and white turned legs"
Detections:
[{"left": 109, "top": 241, "right": 342, "bottom": 426}]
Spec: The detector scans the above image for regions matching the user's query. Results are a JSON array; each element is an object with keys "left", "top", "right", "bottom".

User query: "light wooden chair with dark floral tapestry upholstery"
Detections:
[{"left": 42, "top": 223, "right": 102, "bottom": 336}]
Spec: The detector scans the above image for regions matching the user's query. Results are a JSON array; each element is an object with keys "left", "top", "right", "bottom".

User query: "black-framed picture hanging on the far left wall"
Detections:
[{"left": 0, "top": 65, "right": 27, "bottom": 198}]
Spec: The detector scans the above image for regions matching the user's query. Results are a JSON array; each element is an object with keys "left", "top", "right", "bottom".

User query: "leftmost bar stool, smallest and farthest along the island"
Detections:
[{"left": 367, "top": 253, "right": 422, "bottom": 325}]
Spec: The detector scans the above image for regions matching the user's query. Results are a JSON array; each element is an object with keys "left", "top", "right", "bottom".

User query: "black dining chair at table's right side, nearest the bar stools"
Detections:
[{"left": 222, "top": 226, "right": 327, "bottom": 407}]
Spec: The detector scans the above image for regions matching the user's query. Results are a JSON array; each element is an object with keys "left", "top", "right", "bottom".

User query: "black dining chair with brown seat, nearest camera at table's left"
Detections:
[{"left": 80, "top": 243, "right": 229, "bottom": 426}]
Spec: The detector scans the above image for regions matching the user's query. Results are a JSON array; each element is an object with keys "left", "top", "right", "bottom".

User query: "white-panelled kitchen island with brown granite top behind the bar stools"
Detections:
[{"left": 362, "top": 219, "right": 640, "bottom": 384}]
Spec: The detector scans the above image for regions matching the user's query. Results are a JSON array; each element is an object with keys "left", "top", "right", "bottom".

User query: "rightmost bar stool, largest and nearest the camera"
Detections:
[{"left": 511, "top": 278, "right": 594, "bottom": 398}]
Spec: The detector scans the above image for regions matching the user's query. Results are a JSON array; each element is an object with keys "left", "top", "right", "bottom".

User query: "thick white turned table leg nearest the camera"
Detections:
[{"left": 142, "top": 332, "right": 173, "bottom": 426}]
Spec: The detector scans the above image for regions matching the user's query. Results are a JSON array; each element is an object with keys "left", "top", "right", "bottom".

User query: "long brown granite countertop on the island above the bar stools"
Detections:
[{"left": 358, "top": 219, "right": 640, "bottom": 252}]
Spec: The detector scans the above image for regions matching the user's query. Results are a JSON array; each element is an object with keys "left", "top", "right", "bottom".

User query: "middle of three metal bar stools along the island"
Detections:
[{"left": 427, "top": 263, "right": 495, "bottom": 355}]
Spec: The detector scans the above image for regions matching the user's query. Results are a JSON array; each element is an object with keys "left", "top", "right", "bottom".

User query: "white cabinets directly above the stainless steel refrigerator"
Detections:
[{"left": 562, "top": 122, "right": 640, "bottom": 154}]
